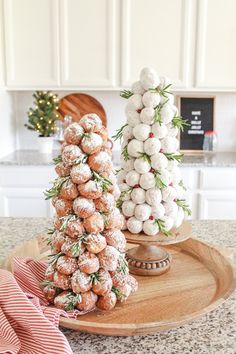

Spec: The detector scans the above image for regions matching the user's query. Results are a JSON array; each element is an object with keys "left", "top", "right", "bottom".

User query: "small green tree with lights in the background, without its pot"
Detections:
[{"left": 25, "top": 91, "right": 60, "bottom": 137}]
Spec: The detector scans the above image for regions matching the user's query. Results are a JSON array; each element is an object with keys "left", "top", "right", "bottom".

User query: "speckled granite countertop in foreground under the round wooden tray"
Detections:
[{"left": 0, "top": 218, "right": 236, "bottom": 354}]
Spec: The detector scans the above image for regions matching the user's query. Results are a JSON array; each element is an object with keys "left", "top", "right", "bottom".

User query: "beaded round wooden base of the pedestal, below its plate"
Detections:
[{"left": 126, "top": 244, "right": 171, "bottom": 275}]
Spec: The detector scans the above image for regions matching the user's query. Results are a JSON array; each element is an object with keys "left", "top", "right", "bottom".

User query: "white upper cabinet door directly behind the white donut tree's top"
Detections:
[{"left": 122, "top": 0, "right": 194, "bottom": 88}]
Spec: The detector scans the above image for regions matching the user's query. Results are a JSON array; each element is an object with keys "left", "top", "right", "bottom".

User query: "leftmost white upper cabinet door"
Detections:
[{"left": 4, "top": 0, "right": 59, "bottom": 88}]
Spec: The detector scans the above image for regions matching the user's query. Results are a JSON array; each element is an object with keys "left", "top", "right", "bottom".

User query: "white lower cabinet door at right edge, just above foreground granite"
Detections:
[{"left": 199, "top": 190, "right": 236, "bottom": 220}]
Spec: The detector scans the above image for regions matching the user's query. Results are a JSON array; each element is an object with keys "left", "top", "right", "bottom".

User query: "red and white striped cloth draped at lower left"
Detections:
[{"left": 0, "top": 258, "right": 83, "bottom": 354}]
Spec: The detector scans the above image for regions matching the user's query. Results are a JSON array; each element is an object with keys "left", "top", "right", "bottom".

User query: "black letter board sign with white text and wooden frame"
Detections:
[{"left": 178, "top": 97, "right": 215, "bottom": 152}]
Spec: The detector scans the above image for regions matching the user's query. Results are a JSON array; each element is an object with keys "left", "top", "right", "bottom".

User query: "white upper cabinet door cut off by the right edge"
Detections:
[{"left": 196, "top": 0, "right": 236, "bottom": 89}]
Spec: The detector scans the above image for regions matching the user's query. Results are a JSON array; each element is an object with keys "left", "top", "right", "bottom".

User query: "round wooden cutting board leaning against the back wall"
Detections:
[{"left": 58, "top": 93, "right": 107, "bottom": 127}]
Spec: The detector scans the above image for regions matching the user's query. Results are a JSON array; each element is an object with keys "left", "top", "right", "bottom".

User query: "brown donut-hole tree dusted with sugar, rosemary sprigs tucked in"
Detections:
[{"left": 43, "top": 113, "right": 137, "bottom": 313}]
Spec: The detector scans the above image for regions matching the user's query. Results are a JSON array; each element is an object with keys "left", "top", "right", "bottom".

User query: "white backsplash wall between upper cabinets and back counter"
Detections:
[{"left": 3, "top": 91, "right": 236, "bottom": 151}]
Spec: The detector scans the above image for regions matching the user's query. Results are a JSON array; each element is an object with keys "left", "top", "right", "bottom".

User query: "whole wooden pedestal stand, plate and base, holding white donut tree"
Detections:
[{"left": 124, "top": 221, "right": 192, "bottom": 275}]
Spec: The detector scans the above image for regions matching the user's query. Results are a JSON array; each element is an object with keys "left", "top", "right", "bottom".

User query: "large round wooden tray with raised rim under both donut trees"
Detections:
[{"left": 6, "top": 237, "right": 236, "bottom": 336}]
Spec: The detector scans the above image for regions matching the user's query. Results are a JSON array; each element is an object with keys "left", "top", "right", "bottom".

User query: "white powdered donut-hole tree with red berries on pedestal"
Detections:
[{"left": 114, "top": 68, "right": 190, "bottom": 236}]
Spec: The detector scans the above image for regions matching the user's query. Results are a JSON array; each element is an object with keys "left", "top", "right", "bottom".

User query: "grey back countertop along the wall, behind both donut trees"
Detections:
[{"left": 0, "top": 150, "right": 236, "bottom": 167}]
